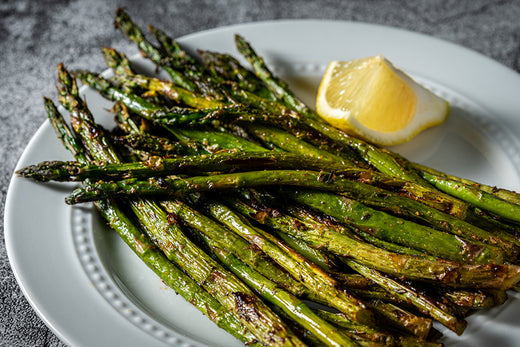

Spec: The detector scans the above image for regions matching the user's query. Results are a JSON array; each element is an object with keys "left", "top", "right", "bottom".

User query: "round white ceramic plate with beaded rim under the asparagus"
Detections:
[{"left": 5, "top": 20, "right": 520, "bottom": 347}]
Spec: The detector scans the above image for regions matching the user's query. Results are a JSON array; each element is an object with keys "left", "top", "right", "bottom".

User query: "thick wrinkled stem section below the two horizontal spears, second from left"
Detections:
[{"left": 131, "top": 201, "right": 302, "bottom": 346}]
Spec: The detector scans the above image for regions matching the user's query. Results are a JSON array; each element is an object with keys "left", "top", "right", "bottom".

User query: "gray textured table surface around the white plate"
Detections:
[{"left": 0, "top": 0, "right": 520, "bottom": 346}]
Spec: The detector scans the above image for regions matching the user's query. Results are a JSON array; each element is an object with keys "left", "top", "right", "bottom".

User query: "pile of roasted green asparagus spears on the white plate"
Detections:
[{"left": 18, "top": 9, "right": 520, "bottom": 346}]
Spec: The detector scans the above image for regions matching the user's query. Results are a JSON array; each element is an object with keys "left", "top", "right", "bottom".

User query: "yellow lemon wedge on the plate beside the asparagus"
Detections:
[{"left": 316, "top": 55, "right": 449, "bottom": 146}]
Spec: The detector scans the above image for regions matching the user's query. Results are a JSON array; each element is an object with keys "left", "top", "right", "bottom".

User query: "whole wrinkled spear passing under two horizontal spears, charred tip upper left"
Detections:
[{"left": 58, "top": 65, "right": 302, "bottom": 346}]
